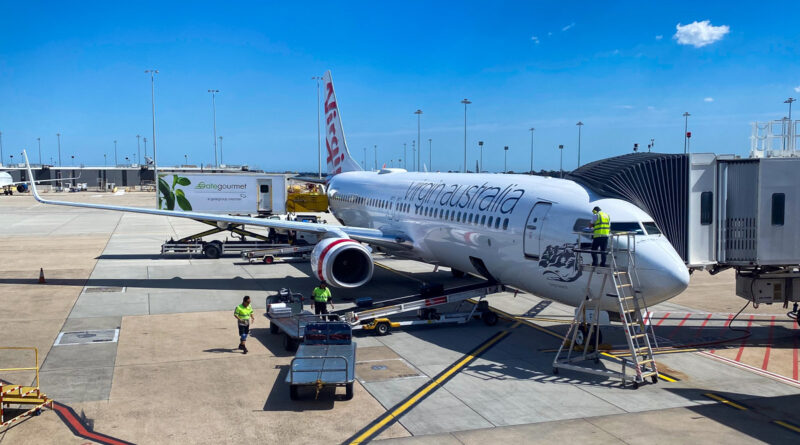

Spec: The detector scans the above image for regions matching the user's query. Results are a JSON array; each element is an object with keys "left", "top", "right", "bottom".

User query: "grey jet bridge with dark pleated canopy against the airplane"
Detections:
[{"left": 569, "top": 126, "right": 800, "bottom": 310}]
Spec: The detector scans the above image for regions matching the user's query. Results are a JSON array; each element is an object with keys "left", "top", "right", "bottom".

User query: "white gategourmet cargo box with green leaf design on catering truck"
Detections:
[{"left": 158, "top": 171, "right": 293, "bottom": 215}]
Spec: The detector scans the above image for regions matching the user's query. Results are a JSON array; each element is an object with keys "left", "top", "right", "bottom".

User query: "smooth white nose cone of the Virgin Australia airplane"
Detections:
[{"left": 636, "top": 238, "right": 689, "bottom": 305}]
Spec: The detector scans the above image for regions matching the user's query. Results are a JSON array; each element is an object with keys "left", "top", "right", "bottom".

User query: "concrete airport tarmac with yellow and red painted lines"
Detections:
[{"left": 0, "top": 192, "right": 800, "bottom": 444}]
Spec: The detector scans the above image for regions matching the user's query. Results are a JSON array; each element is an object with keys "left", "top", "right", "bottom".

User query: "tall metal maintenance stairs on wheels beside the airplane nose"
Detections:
[{"left": 553, "top": 232, "right": 658, "bottom": 389}]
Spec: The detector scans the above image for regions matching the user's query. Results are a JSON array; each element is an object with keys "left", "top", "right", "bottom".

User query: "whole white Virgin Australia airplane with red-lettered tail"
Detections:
[{"left": 25, "top": 71, "right": 689, "bottom": 312}]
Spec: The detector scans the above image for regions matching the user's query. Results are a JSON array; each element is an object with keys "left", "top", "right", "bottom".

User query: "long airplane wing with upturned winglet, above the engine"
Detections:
[{"left": 22, "top": 151, "right": 408, "bottom": 248}]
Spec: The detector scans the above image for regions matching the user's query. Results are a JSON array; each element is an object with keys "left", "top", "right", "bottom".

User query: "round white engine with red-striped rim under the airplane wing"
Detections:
[{"left": 311, "top": 238, "right": 375, "bottom": 288}]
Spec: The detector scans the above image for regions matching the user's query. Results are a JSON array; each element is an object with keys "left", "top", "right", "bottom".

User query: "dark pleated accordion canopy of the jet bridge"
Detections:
[{"left": 568, "top": 153, "right": 689, "bottom": 261}]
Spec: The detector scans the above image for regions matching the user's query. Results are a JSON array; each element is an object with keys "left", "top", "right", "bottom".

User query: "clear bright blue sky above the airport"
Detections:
[{"left": 0, "top": 0, "right": 800, "bottom": 171}]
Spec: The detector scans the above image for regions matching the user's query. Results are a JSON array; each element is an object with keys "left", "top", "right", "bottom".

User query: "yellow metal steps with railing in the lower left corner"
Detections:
[{"left": 0, "top": 347, "right": 53, "bottom": 428}]
